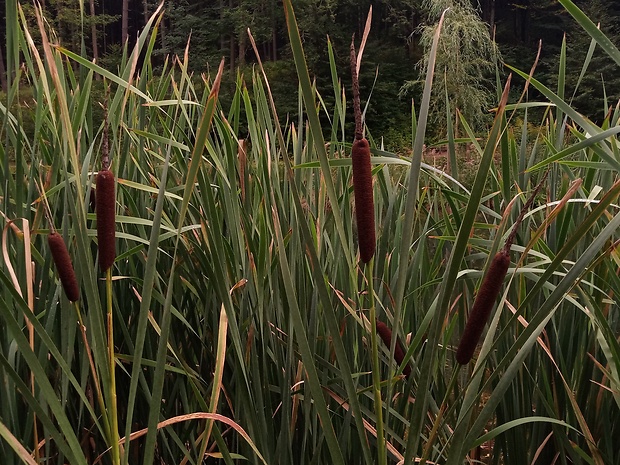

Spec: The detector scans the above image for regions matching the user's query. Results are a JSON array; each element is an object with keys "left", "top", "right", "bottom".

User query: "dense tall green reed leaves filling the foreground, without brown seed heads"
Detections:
[{"left": 0, "top": 0, "right": 620, "bottom": 465}]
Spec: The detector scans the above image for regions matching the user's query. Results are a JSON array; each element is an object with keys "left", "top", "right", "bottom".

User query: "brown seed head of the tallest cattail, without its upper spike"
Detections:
[{"left": 351, "top": 139, "right": 376, "bottom": 263}]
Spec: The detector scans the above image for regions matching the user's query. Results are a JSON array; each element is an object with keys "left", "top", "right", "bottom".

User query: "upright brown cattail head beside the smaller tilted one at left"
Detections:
[{"left": 95, "top": 169, "right": 116, "bottom": 271}]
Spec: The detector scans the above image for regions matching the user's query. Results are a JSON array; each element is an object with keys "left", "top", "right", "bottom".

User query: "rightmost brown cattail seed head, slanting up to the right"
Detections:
[{"left": 456, "top": 249, "right": 510, "bottom": 365}]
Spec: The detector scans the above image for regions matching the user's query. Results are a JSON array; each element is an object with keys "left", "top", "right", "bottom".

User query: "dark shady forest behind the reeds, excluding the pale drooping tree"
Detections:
[{"left": 0, "top": 0, "right": 620, "bottom": 151}]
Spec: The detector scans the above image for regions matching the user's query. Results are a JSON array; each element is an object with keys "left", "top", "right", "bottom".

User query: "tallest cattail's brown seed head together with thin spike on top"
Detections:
[{"left": 351, "top": 41, "right": 376, "bottom": 263}]
